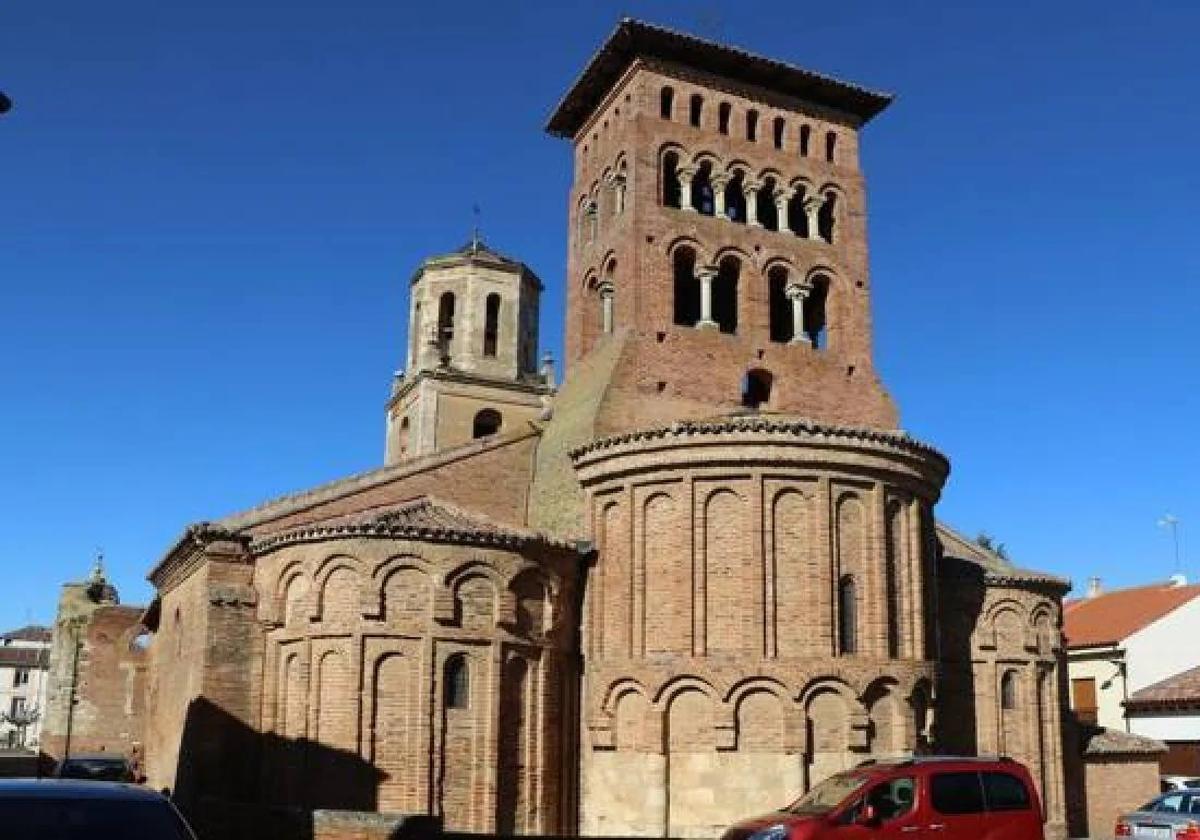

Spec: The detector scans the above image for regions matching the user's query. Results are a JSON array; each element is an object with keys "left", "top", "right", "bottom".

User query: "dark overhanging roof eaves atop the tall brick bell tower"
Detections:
[{"left": 546, "top": 18, "right": 892, "bottom": 138}]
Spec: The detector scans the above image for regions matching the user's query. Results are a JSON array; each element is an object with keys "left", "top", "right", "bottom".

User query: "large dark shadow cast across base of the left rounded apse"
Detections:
[{"left": 172, "top": 697, "right": 437, "bottom": 840}]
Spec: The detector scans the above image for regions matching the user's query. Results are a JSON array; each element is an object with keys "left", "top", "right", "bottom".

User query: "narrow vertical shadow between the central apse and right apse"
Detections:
[{"left": 935, "top": 557, "right": 986, "bottom": 755}]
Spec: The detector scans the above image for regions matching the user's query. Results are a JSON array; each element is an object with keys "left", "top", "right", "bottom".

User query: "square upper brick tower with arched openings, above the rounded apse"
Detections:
[{"left": 547, "top": 20, "right": 898, "bottom": 428}]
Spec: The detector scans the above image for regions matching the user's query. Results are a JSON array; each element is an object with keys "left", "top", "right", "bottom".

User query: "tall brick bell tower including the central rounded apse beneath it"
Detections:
[{"left": 544, "top": 19, "right": 949, "bottom": 838}]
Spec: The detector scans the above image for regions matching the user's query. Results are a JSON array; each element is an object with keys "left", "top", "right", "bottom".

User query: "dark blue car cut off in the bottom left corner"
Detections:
[{"left": 0, "top": 779, "right": 196, "bottom": 840}]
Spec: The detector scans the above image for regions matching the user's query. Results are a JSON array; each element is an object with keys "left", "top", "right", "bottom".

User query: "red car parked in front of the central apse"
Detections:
[{"left": 722, "top": 756, "right": 1046, "bottom": 840}]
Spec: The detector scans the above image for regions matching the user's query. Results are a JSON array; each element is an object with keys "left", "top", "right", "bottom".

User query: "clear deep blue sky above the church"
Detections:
[{"left": 0, "top": 0, "right": 1200, "bottom": 628}]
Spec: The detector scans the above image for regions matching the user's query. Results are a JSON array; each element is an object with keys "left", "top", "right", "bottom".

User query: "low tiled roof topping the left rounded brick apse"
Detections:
[{"left": 251, "top": 497, "right": 574, "bottom": 552}]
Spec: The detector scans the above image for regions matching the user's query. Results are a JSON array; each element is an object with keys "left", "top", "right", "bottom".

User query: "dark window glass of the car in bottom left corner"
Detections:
[{"left": 0, "top": 797, "right": 194, "bottom": 840}]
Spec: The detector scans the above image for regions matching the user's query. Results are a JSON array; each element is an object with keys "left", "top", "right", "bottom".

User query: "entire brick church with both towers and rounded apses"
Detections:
[{"left": 49, "top": 19, "right": 1069, "bottom": 838}]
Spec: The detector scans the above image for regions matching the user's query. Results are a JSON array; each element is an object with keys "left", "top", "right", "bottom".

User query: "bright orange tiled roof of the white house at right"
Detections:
[{"left": 1063, "top": 583, "right": 1200, "bottom": 649}]
